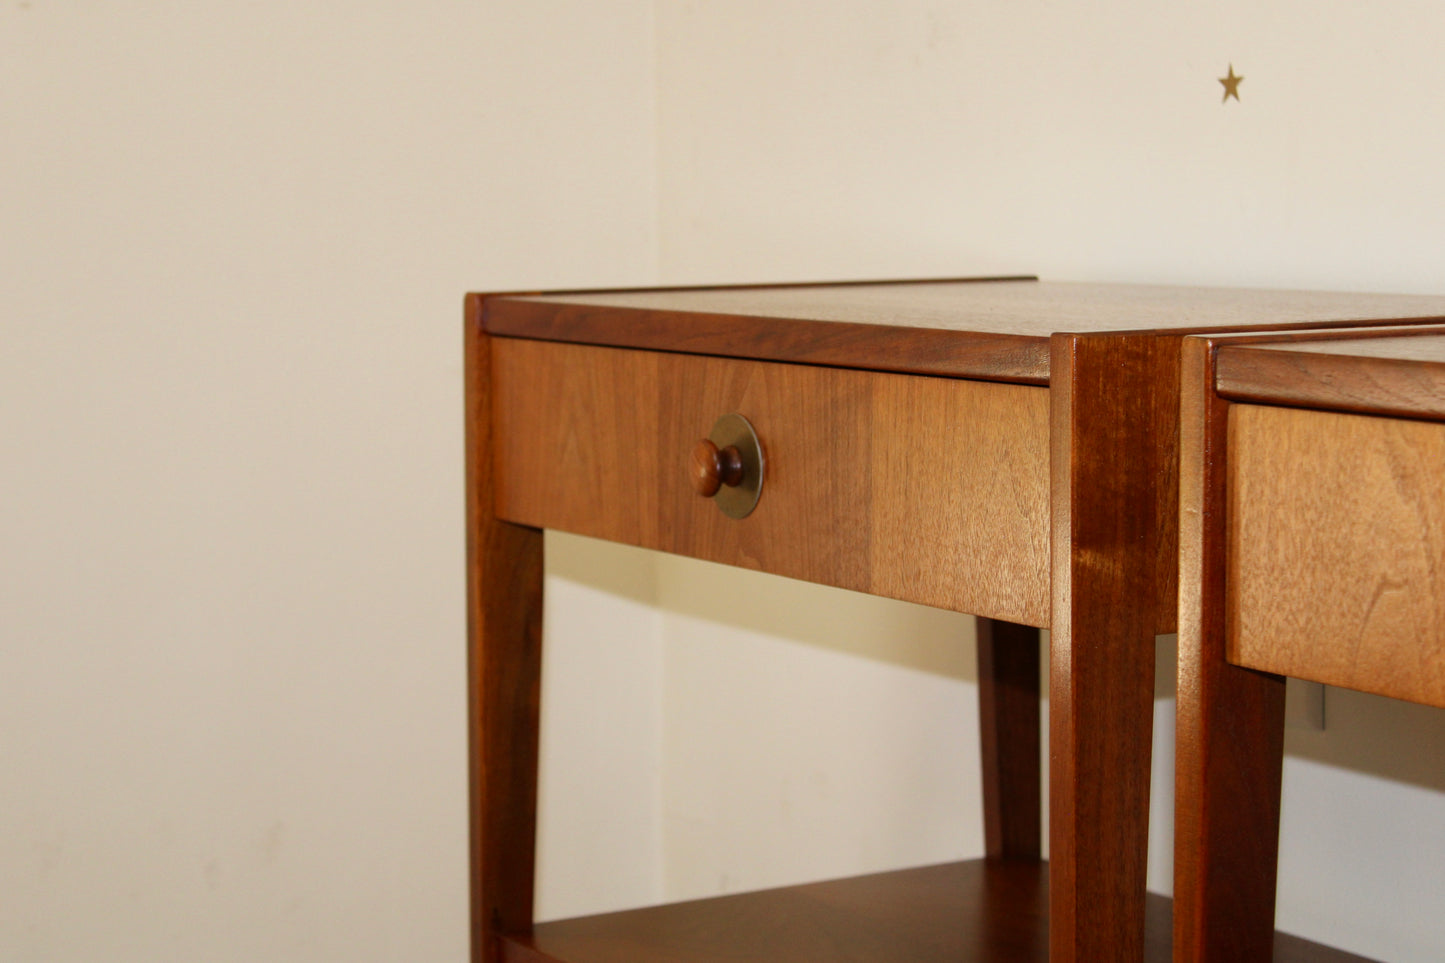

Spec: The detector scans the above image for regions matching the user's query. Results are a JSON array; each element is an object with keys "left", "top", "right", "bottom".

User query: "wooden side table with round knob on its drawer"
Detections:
[{"left": 467, "top": 279, "right": 1445, "bottom": 963}]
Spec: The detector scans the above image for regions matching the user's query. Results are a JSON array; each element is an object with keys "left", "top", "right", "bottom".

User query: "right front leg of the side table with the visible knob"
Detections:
[{"left": 1049, "top": 335, "right": 1179, "bottom": 963}]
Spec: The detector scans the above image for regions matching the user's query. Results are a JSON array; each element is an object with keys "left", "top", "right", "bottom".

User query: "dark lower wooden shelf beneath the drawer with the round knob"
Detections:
[{"left": 501, "top": 859, "right": 1364, "bottom": 963}]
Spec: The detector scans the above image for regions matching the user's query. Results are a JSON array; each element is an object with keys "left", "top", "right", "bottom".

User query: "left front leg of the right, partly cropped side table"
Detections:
[{"left": 1173, "top": 338, "right": 1285, "bottom": 963}]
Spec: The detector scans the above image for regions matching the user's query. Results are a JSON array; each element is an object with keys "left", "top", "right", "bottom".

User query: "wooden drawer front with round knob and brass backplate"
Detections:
[{"left": 493, "top": 338, "right": 1049, "bottom": 626}]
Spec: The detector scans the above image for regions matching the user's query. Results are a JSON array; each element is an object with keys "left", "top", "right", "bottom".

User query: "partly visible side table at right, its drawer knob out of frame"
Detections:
[{"left": 1175, "top": 327, "right": 1445, "bottom": 963}]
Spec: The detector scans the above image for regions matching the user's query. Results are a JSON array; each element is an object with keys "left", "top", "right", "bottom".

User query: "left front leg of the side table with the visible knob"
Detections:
[{"left": 464, "top": 296, "right": 542, "bottom": 963}]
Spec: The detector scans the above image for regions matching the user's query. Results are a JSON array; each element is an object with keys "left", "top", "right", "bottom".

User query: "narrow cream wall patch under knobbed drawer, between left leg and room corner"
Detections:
[{"left": 535, "top": 532, "right": 669, "bottom": 920}]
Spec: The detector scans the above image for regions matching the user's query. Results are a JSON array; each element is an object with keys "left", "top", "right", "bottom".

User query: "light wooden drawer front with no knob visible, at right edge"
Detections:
[{"left": 1225, "top": 405, "right": 1445, "bottom": 706}]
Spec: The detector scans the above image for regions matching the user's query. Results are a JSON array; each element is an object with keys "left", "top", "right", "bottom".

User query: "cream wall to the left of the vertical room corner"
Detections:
[{"left": 0, "top": 0, "right": 657, "bottom": 963}]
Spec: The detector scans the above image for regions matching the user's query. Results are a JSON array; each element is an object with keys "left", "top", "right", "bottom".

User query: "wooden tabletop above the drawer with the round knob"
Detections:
[{"left": 483, "top": 279, "right": 1445, "bottom": 383}]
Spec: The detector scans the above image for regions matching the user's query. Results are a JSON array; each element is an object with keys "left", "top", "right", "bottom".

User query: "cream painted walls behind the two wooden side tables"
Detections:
[{"left": 11, "top": 0, "right": 1445, "bottom": 962}]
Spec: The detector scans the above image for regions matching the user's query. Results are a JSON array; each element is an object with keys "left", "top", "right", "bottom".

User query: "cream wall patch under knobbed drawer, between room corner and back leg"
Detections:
[{"left": 657, "top": 557, "right": 983, "bottom": 899}]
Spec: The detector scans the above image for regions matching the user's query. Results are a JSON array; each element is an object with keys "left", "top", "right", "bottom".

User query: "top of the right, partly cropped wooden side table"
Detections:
[{"left": 1217, "top": 325, "right": 1445, "bottom": 421}]
